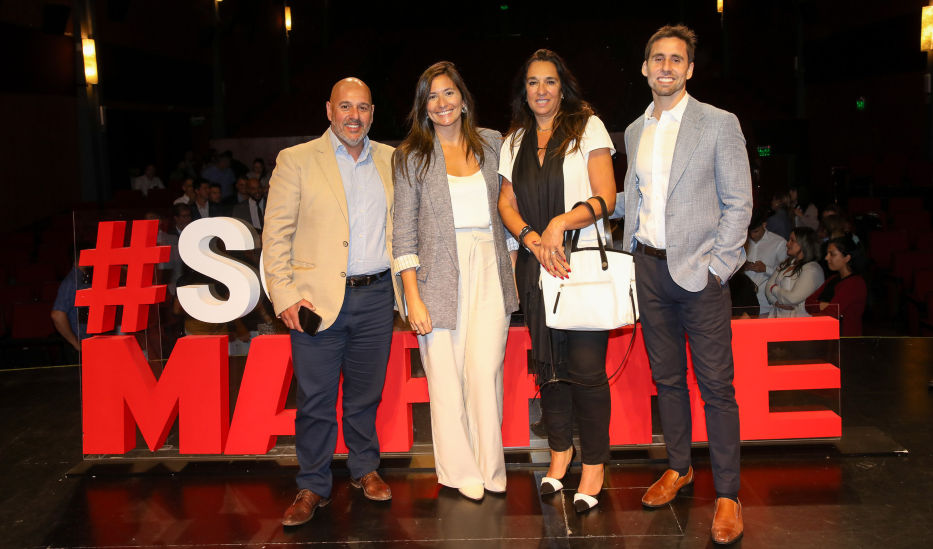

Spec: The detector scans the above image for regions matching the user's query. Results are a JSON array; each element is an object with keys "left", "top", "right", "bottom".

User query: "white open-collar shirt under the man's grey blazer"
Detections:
[{"left": 635, "top": 93, "right": 690, "bottom": 250}]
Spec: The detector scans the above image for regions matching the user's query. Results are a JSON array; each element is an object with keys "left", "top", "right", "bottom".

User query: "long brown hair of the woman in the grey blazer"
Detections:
[{"left": 392, "top": 61, "right": 486, "bottom": 182}]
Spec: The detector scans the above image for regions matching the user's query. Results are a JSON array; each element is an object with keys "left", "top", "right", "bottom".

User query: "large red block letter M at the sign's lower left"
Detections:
[{"left": 81, "top": 336, "right": 230, "bottom": 454}]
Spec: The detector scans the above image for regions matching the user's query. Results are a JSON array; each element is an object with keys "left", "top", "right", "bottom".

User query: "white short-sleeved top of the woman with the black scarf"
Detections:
[{"left": 499, "top": 116, "right": 616, "bottom": 246}]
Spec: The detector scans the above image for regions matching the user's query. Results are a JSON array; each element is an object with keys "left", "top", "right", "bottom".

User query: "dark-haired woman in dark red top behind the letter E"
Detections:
[{"left": 806, "top": 236, "right": 868, "bottom": 337}]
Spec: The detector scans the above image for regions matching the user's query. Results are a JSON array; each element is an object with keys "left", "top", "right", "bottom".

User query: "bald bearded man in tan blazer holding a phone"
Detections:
[{"left": 263, "top": 78, "right": 401, "bottom": 526}]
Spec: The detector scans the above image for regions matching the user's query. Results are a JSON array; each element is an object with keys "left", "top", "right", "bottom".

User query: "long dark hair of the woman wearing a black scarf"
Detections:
[{"left": 506, "top": 48, "right": 593, "bottom": 156}]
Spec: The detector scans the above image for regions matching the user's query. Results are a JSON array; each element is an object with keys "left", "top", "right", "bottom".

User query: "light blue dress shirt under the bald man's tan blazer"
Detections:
[{"left": 328, "top": 131, "right": 389, "bottom": 276}]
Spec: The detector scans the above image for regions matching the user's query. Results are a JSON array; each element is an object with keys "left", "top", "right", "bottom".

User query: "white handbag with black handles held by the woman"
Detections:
[{"left": 538, "top": 197, "right": 638, "bottom": 330}]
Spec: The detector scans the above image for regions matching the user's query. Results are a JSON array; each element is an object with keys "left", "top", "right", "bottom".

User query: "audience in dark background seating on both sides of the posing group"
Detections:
[{"left": 0, "top": 142, "right": 933, "bottom": 362}]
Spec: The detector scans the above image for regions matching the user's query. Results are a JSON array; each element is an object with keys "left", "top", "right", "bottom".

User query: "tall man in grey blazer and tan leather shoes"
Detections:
[{"left": 616, "top": 26, "right": 752, "bottom": 544}]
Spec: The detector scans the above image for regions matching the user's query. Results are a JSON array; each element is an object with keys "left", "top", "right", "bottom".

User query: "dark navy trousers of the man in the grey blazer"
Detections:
[{"left": 635, "top": 251, "right": 740, "bottom": 497}]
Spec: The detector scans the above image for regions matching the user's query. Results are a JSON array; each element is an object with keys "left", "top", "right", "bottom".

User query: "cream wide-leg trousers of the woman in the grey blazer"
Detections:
[{"left": 418, "top": 229, "right": 510, "bottom": 492}]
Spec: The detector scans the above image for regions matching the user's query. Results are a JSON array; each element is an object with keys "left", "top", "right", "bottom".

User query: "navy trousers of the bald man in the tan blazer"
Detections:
[{"left": 291, "top": 274, "right": 394, "bottom": 497}]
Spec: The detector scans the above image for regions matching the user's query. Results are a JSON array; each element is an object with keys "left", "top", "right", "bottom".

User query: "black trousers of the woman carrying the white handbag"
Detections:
[{"left": 541, "top": 331, "right": 611, "bottom": 465}]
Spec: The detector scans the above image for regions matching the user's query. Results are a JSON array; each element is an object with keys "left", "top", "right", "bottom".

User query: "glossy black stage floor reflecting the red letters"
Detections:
[{"left": 0, "top": 338, "right": 933, "bottom": 549}]
